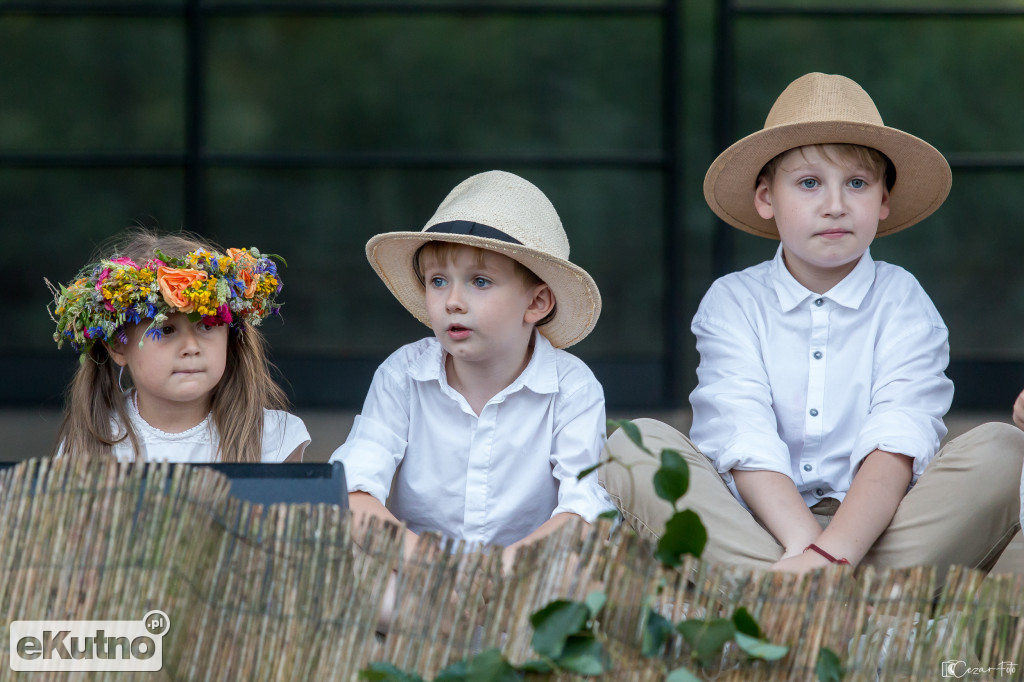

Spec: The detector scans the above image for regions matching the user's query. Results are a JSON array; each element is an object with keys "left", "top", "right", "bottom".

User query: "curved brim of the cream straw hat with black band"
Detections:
[{"left": 367, "top": 231, "right": 601, "bottom": 348}]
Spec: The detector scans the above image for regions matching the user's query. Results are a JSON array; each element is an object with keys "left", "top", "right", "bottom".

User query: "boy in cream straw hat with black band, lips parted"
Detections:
[{"left": 331, "top": 171, "right": 611, "bottom": 563}]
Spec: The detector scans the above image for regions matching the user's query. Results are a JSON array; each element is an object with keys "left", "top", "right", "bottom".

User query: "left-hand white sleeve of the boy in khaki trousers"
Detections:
[{"left": 690, "top": 287, "right": 792, "bottom": 482}]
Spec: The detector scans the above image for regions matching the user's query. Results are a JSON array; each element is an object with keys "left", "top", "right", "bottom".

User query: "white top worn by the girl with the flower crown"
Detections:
[{"left": 107, "top": 394, "right": 309, "bottom": 463}]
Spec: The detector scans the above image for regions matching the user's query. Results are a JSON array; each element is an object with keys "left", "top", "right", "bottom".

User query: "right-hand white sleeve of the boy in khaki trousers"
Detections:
[{"left": 851, "top": 307, "right": 953, "bottom": 479}]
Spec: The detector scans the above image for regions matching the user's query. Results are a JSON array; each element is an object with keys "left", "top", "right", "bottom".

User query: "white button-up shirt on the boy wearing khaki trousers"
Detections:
[{"left": 690, "top": 247, "right": 953, "bottom": 506}]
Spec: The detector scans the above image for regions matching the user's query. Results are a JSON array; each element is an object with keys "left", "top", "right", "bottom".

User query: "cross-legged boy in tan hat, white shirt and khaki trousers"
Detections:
[{"left": 605, "top": 74, "right": 1024, "bottom": 572}]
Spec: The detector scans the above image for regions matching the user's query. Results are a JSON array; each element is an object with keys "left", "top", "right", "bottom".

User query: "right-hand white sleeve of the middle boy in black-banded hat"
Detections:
[{"left": 551, "top": 371, "right": 614, "bottom": 523}]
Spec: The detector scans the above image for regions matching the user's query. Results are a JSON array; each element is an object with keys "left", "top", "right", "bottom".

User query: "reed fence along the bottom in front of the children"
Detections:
[{"left": 0, "top": 460, "right": 1024, "bottom": 682}]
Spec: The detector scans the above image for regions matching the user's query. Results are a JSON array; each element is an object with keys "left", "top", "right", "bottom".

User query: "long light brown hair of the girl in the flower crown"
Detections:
[{"left": 54, "top": 229, "right": 289, "bottom": 462}]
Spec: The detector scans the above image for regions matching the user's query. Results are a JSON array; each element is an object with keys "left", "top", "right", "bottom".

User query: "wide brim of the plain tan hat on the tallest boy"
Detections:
[{"left": 703, "top": 121, "right": 952, "bottom": 240}]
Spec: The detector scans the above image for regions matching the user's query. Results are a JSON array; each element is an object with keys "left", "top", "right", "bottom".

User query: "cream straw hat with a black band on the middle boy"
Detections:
[{"left": 367, "top": 171, "right": 601, "bottom": 348}]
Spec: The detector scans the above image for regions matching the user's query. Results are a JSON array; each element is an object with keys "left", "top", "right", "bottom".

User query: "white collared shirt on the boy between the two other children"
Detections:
[{"left": 331, "top": 334, "right": 613, "bottom": 546}]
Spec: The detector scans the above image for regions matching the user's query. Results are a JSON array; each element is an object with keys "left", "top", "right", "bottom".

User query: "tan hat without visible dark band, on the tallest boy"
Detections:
[{"left": 703, "top": 73, "right": 952, "bottom": 240}]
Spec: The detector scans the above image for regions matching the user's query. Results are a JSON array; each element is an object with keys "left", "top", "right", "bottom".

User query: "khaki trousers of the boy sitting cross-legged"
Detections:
[{"left": 599, "top": 419, "right": 1024, "bottom": 570}]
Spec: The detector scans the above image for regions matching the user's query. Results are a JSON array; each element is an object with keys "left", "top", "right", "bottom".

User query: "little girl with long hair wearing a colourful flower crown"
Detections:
[{"left": 47, "top": 230, "right": 309, "bottom": 462}]
